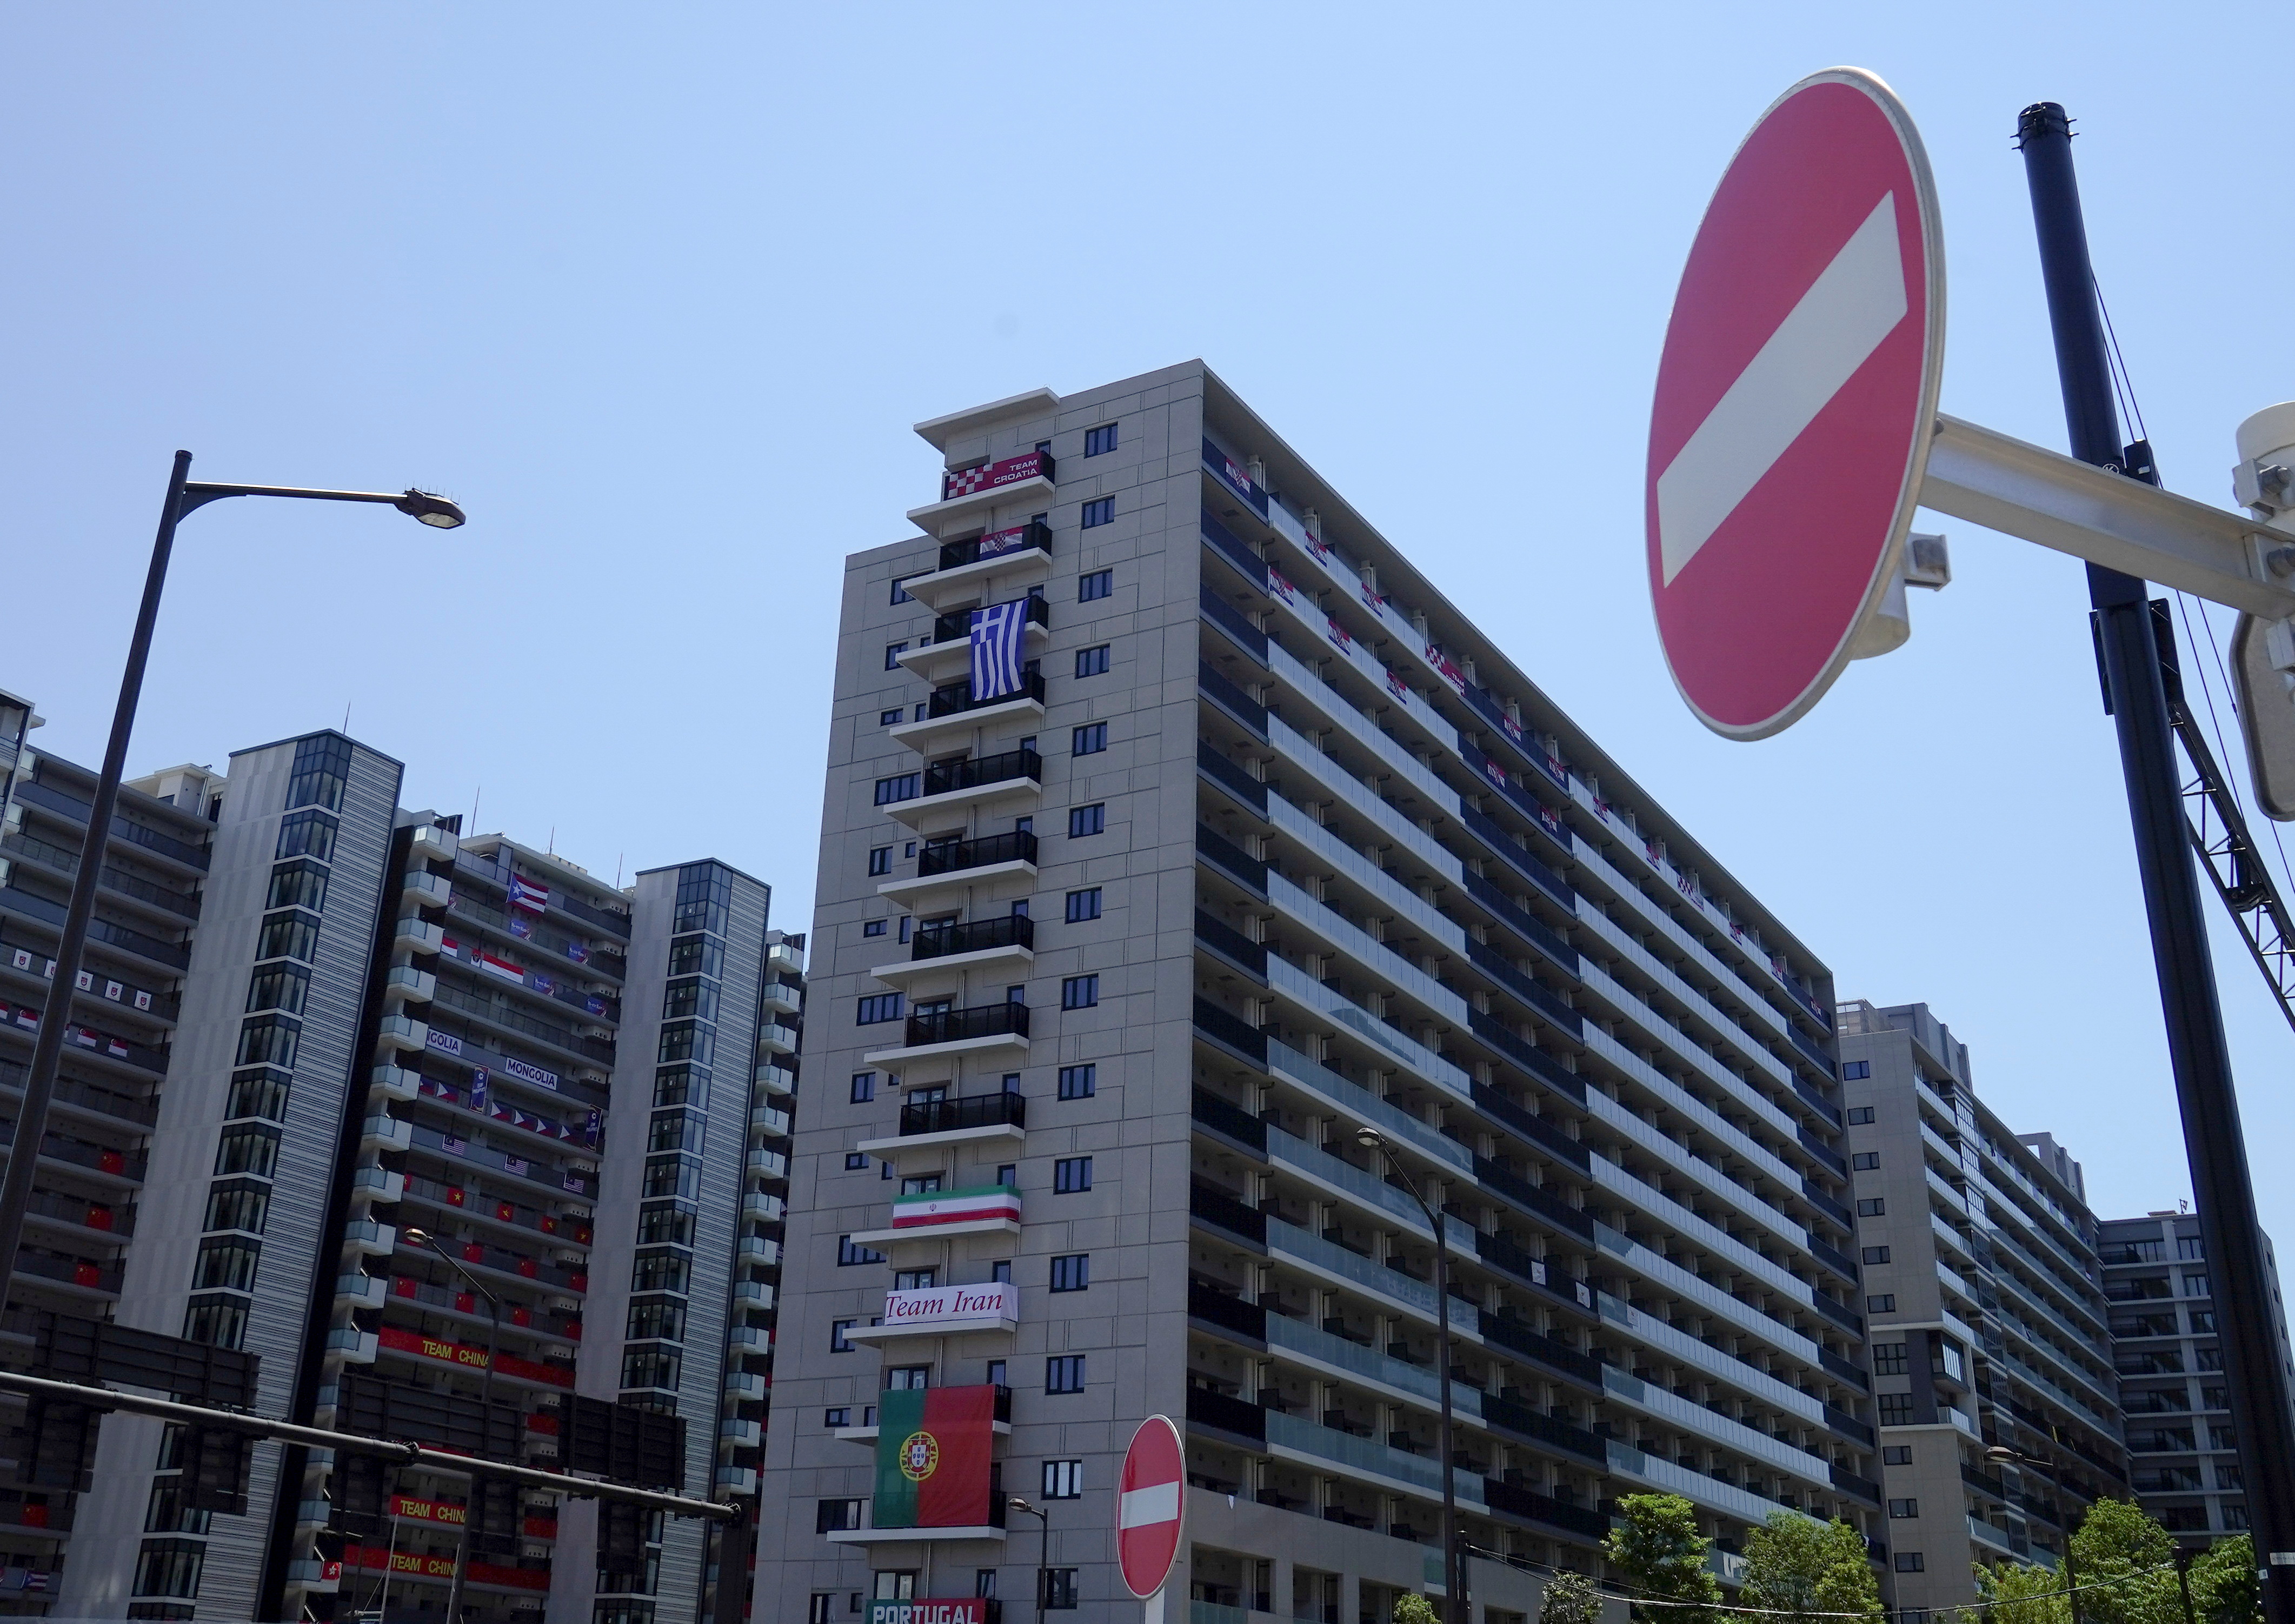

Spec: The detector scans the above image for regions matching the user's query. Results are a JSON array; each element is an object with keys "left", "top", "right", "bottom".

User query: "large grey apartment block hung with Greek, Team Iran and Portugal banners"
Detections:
[{"left": 760, "top": 362, "right": 1880, "bottom": 1624}]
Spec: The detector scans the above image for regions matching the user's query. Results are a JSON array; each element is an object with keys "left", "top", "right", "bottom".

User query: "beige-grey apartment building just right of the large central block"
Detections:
[{"left": 1838, "top": 1000, "right": 2127, "bottom": 1610}]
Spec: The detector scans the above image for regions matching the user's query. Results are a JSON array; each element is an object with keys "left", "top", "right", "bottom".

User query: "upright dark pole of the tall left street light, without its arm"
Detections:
[{"left": 0, "top": 452, "right": 190, "bottom": 1319}]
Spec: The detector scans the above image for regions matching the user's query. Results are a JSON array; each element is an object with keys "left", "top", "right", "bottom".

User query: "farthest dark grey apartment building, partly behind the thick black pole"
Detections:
[{"left": 2098, "top": 1211, "right": 2295, "bottom": 1541}]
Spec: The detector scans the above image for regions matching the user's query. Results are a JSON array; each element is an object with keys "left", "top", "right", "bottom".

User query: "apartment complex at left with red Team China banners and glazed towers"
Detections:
[{"left": 0, "top": 707, "right": 803, "bottom": 1624}]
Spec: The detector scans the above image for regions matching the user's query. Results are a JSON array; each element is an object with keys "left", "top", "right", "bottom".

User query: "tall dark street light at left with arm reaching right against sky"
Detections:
[{"left": 0, "top": 452, "right": 463, "bottom": 1316}]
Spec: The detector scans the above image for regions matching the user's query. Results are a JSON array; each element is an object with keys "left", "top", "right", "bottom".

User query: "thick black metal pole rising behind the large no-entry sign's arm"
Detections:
[{"left": 2017, "top": 101, "right": 2295, "bottom": 1624}]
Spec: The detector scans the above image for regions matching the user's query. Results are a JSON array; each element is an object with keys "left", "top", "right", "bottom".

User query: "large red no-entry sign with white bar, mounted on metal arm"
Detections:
[{"left": 1643, "top": 69, "right": 1944, "bottom": 738}]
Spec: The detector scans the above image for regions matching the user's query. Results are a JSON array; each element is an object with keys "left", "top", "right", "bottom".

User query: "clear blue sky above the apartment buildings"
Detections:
[{"left": 0, "top": 4, "right": 2295, "bottom": 1246}]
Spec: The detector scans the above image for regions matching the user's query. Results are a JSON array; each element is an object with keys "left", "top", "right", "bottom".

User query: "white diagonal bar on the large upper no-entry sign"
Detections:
[{"left": 1657, "top": 192, "right": 1910, "bottom": 585}]
